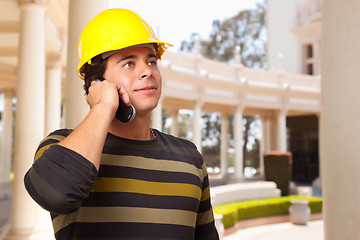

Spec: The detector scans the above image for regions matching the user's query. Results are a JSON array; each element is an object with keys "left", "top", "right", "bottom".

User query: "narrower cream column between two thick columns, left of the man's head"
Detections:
[{"left": 45, "top": 53, "right": 62, "bottom": 135}]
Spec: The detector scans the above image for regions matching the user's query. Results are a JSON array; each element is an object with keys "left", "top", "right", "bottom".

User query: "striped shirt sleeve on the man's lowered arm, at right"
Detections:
[{"left": 195, "top": 164, "right": 219, "bottom": 240}]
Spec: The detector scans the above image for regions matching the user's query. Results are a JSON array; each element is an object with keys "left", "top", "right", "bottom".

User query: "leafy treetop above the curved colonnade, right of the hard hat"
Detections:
[{"left": 180, "top": 2, "right": 266, "bottom": 68}]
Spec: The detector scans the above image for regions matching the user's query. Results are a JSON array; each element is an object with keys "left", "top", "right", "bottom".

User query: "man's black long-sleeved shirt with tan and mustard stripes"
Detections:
[{"left": 25, "top": 129, "right": 219, "bottom": 240}]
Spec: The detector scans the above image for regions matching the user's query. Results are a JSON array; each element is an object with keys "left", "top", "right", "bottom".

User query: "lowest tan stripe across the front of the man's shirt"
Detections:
[{"left": 53, "top": 207, "right": 196, "bottom": 232}]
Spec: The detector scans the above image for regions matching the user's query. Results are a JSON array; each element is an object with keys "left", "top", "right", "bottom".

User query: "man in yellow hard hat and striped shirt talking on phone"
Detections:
[{"left": 25, "top": 9, "right": 219, "bottom": 240}]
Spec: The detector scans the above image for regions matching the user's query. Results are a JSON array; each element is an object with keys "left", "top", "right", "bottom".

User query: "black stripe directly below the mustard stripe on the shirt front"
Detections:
[{"left": 82, "top": 192, "right": 200, "bottom": 212}]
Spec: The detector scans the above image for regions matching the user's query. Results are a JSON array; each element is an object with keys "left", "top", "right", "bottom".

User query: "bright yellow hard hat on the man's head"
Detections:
[{"left": 78, "top": 8, "right": 172, "bottom": 70}]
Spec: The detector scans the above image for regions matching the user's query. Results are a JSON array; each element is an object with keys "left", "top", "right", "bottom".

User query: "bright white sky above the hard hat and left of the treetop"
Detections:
[{"left": 108, "top": 0, "right": 261, "bottom": 51}]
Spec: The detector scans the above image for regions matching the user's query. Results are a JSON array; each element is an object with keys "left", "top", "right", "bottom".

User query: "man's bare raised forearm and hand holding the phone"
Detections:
[{"left": 59, "top": 80, "right": 130, "bottom": 169}]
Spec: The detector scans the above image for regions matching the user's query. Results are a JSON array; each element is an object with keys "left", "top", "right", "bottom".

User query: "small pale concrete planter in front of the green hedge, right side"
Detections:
[{"left": 289, "top": 199, "right": 311, "bottom": 225}]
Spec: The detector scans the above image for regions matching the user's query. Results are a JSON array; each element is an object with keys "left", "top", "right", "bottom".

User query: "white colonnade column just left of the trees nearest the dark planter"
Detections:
[{"left": 234, "top": 106, "right": 244, "bottom": 179}]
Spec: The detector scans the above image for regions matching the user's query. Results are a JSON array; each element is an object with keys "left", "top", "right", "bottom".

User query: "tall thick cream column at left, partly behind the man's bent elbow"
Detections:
[{"left": 6, "top": 1, "right": 46, "bottom": 239}]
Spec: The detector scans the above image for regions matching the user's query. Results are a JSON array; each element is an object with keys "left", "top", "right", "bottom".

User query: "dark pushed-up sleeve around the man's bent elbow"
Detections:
[{"left": 24, "top": 132, "right": 97, "bottom": 214}]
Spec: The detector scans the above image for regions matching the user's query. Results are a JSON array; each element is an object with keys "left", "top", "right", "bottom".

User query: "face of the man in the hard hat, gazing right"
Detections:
[{"left": 104, "top": 47, "right": 161, "bottom": 115}]
